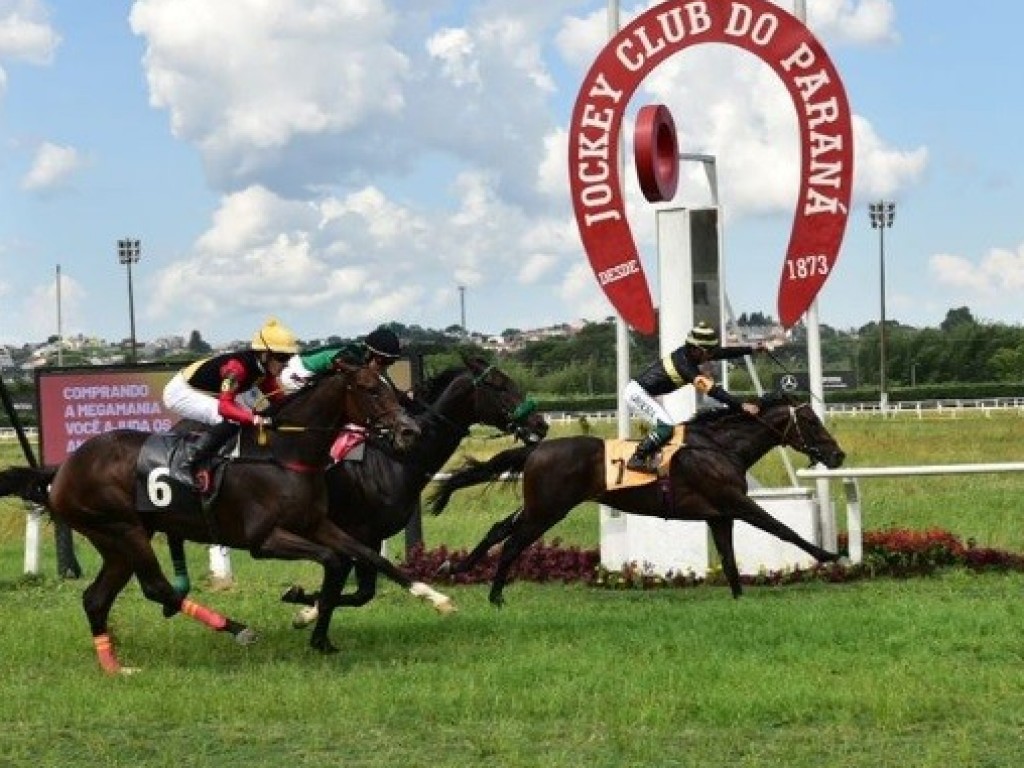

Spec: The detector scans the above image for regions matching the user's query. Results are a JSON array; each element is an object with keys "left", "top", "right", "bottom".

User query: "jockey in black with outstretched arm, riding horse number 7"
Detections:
[{"left": 623, "top": 323, "right": 770, "bottom": 474}]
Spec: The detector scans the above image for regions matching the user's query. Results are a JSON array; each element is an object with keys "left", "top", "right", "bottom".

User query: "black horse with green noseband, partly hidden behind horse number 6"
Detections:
[{"left": 260, "top": 357, "right": 548, "bottom": 627}]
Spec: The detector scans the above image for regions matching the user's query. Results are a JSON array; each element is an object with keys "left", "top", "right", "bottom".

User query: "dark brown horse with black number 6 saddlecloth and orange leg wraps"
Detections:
[{"left": 0, "top": 367, "right": 450, "bottom": 673}]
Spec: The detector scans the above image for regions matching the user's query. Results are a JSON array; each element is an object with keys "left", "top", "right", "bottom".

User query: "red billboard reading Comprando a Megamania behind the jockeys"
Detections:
[{"left": 36, "top": 365, "right": 179, "bottom": 466}]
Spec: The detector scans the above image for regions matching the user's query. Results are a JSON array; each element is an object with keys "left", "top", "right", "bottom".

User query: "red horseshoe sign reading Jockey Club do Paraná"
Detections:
[{"left": 568, "top": 0, "right": 853, "bottom": 334}]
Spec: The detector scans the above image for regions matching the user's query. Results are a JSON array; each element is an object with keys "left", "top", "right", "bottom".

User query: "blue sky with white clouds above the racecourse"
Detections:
[{"left": 0, "top": 0, "right": 1024, "bottom": 345}]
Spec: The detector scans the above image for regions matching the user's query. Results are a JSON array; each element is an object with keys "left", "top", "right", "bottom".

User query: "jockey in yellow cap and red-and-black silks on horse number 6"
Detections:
[{"left": 164, "top": 317, "right": 299, "bottom": 494}]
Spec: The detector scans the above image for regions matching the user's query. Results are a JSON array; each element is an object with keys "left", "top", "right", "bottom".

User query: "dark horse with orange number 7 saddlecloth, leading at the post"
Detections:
[{"left": 431, "top": 395, "right": 846, "bottom": 605}]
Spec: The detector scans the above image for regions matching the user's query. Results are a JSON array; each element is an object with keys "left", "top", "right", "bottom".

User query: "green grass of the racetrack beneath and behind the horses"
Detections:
[{"left": 0, "top": 415, "right": 1024, "bottom": 768}]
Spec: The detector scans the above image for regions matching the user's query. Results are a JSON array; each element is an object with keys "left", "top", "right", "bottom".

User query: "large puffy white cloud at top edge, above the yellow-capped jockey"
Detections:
[{"left": 130, "top": 0, "right": 409, "bottom": 189}]
